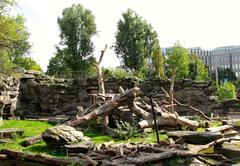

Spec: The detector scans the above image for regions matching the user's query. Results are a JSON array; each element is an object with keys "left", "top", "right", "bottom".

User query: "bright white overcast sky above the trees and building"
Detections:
[{"left": 15, "top": 0, "right": 240, "bottom": 71}]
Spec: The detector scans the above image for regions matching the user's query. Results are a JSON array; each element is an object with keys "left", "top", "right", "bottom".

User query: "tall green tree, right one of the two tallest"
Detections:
[{"left": 113, "top": 9, "right": 159, "bottom": 73}]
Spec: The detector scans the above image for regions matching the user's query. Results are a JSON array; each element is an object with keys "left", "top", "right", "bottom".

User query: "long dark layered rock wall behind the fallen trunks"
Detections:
[{"left": 0, "top": 71, "right": 240, "bottom": 118}]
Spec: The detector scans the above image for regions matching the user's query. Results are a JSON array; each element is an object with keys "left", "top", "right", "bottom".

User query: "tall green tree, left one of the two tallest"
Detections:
[{"left": 58, "top": 4, "right": 97, "bottom": 73}]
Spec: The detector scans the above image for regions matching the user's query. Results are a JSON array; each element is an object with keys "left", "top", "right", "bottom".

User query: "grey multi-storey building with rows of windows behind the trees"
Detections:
[{"left": 188, "top": 45, "right": 240, "bottom": 77}]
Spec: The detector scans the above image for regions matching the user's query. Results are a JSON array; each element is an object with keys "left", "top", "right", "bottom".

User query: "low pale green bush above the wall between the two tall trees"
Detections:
[{"left": 103, "top": 68, "right": 132, "bottom": 79}]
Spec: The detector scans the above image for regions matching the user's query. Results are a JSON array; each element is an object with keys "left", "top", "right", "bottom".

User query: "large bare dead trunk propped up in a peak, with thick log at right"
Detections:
[{"left": 66, "top": 87, "right": 198, "bottom": 129}]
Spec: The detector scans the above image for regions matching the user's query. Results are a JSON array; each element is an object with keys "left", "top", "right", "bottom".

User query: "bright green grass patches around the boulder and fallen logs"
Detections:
[{"left": 0, "top": 120, "right": 168, "bottom": 157}]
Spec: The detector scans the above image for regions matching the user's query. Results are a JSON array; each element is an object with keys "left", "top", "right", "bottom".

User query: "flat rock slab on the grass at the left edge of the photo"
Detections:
[{"left": 0, "top": 128, "right": 24, "bottom": 138}]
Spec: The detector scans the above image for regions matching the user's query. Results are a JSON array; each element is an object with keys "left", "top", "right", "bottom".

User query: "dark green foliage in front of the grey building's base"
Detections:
[{"left": 212, "top": 68, "right": 237, "bottom": 82}]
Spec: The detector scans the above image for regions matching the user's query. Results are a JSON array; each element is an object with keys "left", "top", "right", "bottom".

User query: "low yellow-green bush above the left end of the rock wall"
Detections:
[{"left": 15, "top": 57, "right": 42, "bottom": 71}]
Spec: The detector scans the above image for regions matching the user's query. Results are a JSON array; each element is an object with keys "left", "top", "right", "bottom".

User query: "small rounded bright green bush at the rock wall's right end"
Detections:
[{"left": 217, "top": 82, "right": 236, "bottom": 100}]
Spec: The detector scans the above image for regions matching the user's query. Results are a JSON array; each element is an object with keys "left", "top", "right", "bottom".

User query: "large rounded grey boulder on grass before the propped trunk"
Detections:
[{"left": 42, "top": 125, "right": 86, "bottom": 148}]
